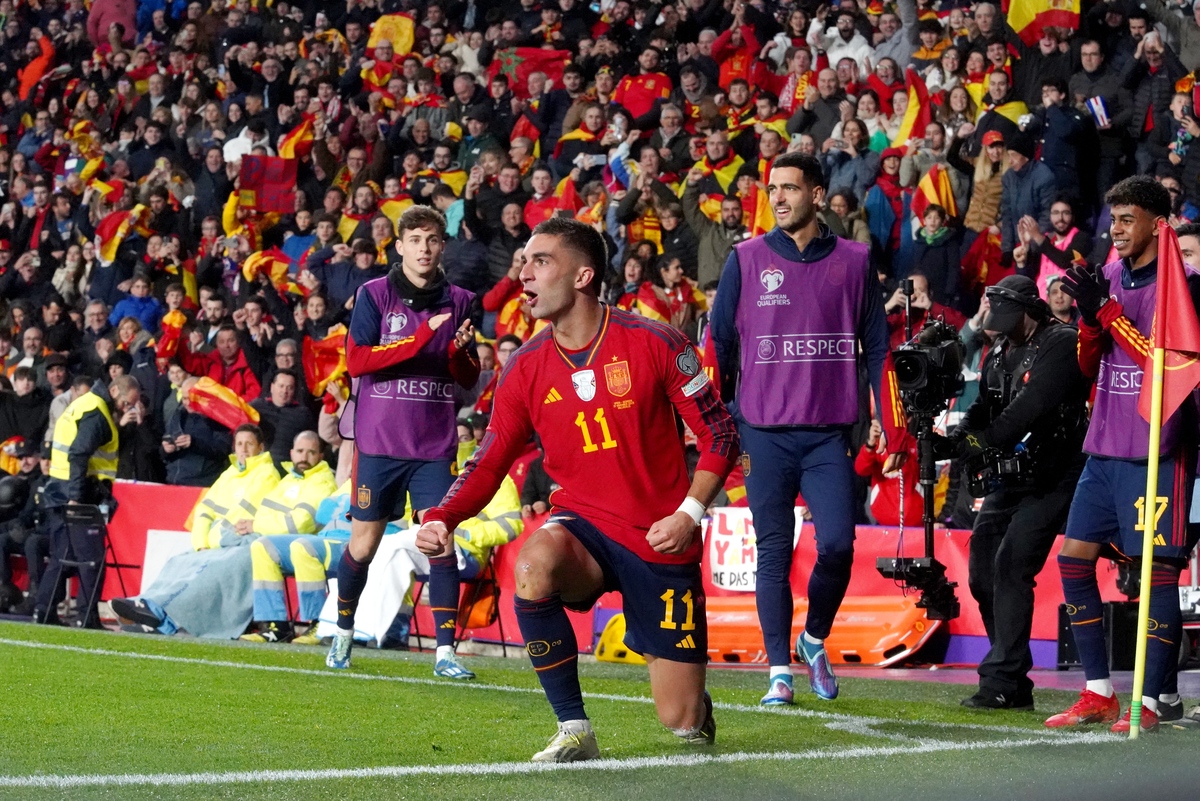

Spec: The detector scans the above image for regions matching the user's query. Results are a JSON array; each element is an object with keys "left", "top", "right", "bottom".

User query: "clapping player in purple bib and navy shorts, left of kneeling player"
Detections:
[{"left": 325, "top": 206, "right": 479, "bottom": 679}]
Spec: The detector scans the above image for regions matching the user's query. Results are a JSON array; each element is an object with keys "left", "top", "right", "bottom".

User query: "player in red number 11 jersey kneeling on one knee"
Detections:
[{"left": 418, "top": 218, "right": 738, "bottom": 761}]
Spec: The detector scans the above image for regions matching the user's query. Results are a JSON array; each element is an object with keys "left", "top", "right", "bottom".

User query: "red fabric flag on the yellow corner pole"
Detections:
[{"left": 1138, "top": 221, "right": 1200, "bottom": 420}]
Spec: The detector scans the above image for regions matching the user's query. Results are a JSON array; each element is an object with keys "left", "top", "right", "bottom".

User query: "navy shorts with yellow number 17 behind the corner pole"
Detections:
[{"left": 1067, "top": 456, "right": 1194, "bottom": 559}]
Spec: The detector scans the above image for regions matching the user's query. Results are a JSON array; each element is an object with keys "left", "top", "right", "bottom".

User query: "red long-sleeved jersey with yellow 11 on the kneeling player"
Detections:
[{"left": 425, "top": 307, "right": 738, "bottom": 564}]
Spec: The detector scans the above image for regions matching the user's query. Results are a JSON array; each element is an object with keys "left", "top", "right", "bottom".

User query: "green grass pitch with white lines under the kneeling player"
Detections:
[{"left": 0, "top": 624, "right": 1200, "bottom": 801}]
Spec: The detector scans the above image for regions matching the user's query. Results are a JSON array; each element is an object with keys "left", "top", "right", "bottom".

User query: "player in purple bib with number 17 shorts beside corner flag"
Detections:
[{"left": 1046, "top": 175, "right": 1200, "bottom": 733}]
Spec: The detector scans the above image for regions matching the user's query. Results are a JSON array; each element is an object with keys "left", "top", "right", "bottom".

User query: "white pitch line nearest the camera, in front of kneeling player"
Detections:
[{"left": 0, "top": 733, "right": 1121, "bottom": 789}]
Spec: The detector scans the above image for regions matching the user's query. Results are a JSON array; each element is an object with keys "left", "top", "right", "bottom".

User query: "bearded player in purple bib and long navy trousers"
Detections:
[{"left": 710, "top": 153, "right": 911, "bottom": 706}]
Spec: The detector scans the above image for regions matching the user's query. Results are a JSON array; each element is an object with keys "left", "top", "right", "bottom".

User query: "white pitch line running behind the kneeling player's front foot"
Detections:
[{"left": 0, "top": 638, "right": 1063, "bottom": 740}]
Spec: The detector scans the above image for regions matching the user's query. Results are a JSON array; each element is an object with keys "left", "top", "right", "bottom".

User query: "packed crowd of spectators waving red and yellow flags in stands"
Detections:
[{"left": 0, "top": 0, "right": 1200, "bottom": 613}]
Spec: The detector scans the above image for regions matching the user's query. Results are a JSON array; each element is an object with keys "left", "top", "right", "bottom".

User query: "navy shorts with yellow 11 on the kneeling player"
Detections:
[{"left": 546, "top": 512, "right": 708, "bottom": 662}]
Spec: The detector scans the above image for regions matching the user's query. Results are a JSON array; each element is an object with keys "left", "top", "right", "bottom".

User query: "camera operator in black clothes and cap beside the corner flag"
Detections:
[{"left": 940, "top": 276, "right": 1088, "bottom": 709}]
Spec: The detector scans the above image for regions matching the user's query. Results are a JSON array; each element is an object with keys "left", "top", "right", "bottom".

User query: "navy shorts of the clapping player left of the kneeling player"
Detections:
[{"left": 350, "top": 453, "right": 457, "bottom": 522}]
